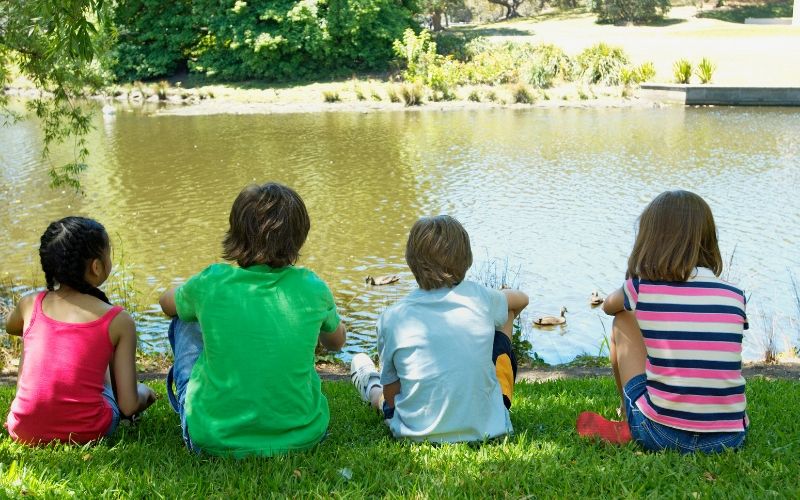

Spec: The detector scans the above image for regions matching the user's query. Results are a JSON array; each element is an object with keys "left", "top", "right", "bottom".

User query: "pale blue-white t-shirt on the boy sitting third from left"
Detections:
[{"left": 378, "top": 281, "right": 512, "bottom": 442}]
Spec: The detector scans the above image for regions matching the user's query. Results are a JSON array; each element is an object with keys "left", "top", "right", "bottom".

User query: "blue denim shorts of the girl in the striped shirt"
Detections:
[{"left": 622, "top": 374, "right": 747, "bottom": 453}]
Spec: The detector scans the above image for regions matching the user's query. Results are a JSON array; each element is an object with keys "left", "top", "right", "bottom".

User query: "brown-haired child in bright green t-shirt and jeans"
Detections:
[{"left": 159, "top": 183, "right": 345, "bottom": 457}]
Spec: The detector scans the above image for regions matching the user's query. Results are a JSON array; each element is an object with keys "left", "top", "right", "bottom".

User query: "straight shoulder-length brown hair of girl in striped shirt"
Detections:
[{"left": 627, "top": 190, "right": 722, "bottom": 281}]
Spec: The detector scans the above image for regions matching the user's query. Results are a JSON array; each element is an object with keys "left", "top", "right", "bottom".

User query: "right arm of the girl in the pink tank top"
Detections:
[{"left": 108, "top": 311, "right": 156, "bottom": 416}]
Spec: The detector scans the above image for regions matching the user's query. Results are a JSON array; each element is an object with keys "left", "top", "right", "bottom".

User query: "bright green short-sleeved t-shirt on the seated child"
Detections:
[{"left": 175, "top": 264, "right": 339, "bottom": 456}]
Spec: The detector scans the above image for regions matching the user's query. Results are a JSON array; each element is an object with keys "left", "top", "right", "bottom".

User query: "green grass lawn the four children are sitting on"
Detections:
[{"left": 0, "top": 379, "right": 800, "bottom": 498}]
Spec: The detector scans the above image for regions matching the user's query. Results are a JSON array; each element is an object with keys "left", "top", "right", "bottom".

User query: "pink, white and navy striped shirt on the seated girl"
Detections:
[{"left": 623, "top": 267, "right": 747, "bottom": 432}]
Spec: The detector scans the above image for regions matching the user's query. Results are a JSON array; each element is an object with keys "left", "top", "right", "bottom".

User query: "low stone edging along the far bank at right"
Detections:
[{"left": 639, "top": 83, "right": 800, "bottom": 106}]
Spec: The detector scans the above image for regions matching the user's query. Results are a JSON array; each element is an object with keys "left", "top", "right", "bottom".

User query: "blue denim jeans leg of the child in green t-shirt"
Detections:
[{"left": 167, "top": 318, "right": 203, "bottom": 453}]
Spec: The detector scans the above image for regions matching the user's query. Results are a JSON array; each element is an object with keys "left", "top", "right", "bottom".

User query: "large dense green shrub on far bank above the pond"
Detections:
[{"left": 187, "top": 0, "right": 414, "bottom": 80}]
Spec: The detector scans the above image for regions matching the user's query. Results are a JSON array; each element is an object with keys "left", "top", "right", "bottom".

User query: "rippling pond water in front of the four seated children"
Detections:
[{"left": 0, "top": 108, "right": 800, "bottom": 363}]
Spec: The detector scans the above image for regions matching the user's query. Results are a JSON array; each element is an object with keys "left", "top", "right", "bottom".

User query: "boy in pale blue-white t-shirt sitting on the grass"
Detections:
[{"left": 351, "top": 215, "right": 528, "bottom": 442}]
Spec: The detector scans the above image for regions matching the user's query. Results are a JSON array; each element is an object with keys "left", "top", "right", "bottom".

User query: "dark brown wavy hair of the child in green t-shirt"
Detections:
[{"left": 222, "top": 182, "right": 311, "bottom": 267}]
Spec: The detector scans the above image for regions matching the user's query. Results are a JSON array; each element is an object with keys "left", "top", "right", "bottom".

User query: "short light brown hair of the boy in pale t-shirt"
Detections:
[{"left": 406, "top": 215, "right": 472, "bottom": 290}]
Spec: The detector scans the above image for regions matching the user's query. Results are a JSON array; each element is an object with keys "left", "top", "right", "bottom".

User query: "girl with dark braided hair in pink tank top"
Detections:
[{"left": 6, "top": 217, "right": 155, "bottom": 444}]
